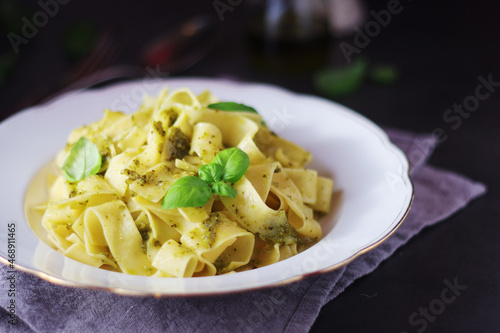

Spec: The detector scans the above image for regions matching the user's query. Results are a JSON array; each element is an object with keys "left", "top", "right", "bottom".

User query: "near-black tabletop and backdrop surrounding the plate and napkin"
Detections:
[{"left": 0, "top": 0, "right": 500, "bottom": 333}]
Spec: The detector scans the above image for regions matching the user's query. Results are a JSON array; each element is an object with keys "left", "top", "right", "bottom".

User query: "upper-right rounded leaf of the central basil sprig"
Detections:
[{"left": 211, "top": 147, "right": 250, "bottom": 183}]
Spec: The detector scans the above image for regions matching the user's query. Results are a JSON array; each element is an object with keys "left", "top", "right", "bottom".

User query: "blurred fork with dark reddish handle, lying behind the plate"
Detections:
[{"left": 14, "top": 15, "right": 221, "bottom": 111}]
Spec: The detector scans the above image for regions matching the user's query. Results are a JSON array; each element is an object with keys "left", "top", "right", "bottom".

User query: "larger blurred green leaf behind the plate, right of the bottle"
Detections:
[{"left": 314, "top": 58, "right": 368, "bottom": 97}]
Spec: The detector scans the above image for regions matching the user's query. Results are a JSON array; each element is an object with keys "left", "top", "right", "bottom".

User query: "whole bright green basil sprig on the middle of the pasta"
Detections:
[{"left": 161, "top": 147, "right": 250, "bottom": 209}]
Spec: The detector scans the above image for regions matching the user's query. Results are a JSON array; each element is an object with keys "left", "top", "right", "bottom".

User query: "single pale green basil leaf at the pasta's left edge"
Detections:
[{"left": 61, "top": 137, "right": 102, "bottom": 182}]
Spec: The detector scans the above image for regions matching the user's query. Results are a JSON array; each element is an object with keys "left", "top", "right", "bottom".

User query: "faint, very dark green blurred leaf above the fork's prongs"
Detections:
[{"left": 63, "top": 21, "right": 99, "bottom": 60}]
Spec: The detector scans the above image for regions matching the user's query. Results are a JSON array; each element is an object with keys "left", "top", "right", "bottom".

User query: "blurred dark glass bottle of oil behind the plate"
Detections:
[{"left": 246, "top": 0, "right": 329, "bottom": 73}]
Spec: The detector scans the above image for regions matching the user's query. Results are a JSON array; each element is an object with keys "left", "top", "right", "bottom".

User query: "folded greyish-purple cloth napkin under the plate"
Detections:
[{"left": 0, "top": 130, "right": 485, "bottom": 333}]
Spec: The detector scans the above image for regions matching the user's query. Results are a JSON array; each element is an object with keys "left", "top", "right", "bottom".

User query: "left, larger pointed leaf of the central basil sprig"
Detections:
[{"left": 161, "top": 176, "right": 212, "bottom": 209}]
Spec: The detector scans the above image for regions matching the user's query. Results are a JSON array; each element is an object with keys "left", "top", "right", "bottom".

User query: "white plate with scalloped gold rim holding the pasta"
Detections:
[{"left": 0, "top": 78, "right": 413, "bottom": 296}]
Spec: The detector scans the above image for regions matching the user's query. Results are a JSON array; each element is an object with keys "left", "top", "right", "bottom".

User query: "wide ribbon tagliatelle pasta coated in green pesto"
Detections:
[{"left": 42, "top": 89, "right": 333, "bottom": 277}]
